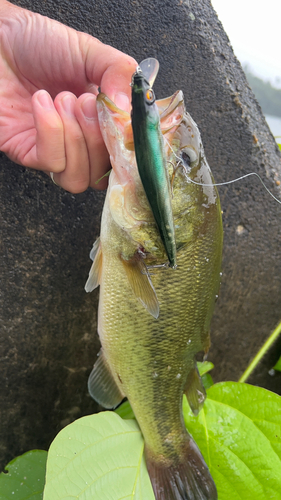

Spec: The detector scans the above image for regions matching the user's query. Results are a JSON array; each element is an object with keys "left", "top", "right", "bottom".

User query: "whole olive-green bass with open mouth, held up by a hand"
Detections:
[{"left": 85, "top": 61, "right": 223, "bottom": 500}]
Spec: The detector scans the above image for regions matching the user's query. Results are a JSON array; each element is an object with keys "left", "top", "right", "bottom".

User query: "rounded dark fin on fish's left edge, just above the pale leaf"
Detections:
[{"left": 88, "top": 349, "right": 125, "bottom": 409}]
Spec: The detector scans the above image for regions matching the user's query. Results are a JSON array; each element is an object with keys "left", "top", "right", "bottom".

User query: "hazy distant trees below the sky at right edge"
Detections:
[{"left": 244, "top": 66, "right": 281, "bottom": 117}]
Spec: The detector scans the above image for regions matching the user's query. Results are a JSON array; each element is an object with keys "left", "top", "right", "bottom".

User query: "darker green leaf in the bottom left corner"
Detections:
[{"left": 0, "top": 450, "right": 47, "bottom": 500}]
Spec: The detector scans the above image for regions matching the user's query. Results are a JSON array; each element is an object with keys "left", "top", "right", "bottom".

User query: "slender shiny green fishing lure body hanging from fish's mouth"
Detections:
[{"left": 131, "top": 69, "right": 176, "bottom": 268}]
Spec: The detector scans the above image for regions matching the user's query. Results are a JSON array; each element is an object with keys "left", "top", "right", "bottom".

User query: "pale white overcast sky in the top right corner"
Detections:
[{"left": 211, "top": 0, "right": 281, "bottom": 88}]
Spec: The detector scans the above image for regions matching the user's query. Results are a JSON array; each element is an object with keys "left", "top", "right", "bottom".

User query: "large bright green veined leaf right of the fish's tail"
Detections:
[{"left": 184, "top": 382, "right": 281, "bottom": 500}]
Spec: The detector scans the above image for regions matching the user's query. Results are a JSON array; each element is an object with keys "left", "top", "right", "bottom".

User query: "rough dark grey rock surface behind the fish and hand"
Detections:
[{"left": 0, "top": 0, "right": 281, "bottom": 465}]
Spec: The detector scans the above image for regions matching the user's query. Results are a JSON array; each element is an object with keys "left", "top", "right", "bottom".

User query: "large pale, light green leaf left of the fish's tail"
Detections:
[{"left": 42, "top": 412, "right": 154, "bottom": 500}]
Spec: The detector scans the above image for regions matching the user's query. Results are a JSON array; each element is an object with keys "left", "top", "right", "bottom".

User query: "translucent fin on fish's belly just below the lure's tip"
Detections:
[{"left": 120, "top": 253, "right": 159, "bottom": 319}]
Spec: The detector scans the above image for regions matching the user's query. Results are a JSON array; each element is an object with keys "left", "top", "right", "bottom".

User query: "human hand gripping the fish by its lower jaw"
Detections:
[{"left": 0, "top": 0, "right": 136, "bottom": 193}]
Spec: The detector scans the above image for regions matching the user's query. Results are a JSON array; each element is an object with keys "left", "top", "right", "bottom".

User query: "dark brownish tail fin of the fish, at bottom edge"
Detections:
[{"left": 146, "top": 438, "right": 215, "bottom": 500}]
